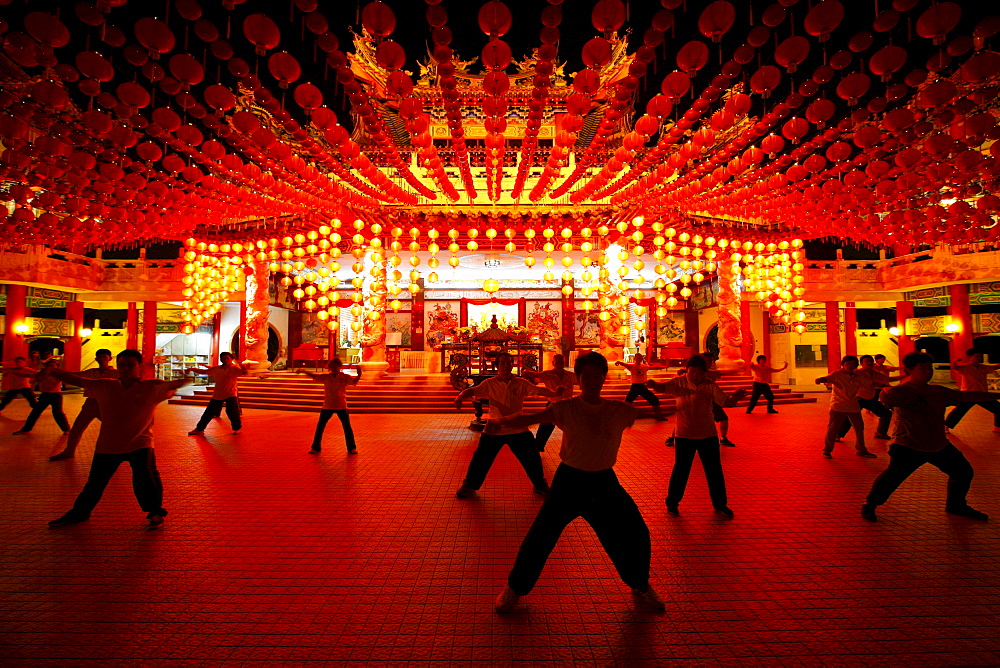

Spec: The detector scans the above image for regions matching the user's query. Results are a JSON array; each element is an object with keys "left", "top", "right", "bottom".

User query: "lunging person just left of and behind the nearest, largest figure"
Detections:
[{"left": 455, "top": 352, "right": 560, "bottom": 499}]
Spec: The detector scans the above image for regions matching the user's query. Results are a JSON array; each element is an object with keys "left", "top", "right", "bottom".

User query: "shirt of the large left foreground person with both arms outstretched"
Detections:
[{"left": 84, "top": 378, "right": 174, "bottom": 455}]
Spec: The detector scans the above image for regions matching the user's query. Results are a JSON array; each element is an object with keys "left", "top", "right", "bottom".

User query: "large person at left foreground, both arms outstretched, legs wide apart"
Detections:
[{"left": 49, "top": 349, "right": 188, "bottom": 529}]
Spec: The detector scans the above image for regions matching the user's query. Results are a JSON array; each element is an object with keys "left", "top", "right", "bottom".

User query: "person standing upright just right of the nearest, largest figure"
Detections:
[{"left": 648, "top": 355, "right": 746, "bottom": 517}]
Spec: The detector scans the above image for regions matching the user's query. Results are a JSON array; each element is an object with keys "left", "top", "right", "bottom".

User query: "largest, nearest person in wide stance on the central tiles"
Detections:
[{"left": 485, "top": 352, "right": 666, "bottom": 613}]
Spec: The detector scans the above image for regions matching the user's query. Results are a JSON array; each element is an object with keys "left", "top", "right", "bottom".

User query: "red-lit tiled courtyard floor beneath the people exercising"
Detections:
[{"left": 0, "top": 397, "right": 1000, "bottom": 665}]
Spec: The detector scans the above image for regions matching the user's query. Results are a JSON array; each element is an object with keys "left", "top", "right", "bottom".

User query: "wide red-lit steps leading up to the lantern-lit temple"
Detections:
[{"left": 170, "top": 369, "right": 816, "bottom": 414}]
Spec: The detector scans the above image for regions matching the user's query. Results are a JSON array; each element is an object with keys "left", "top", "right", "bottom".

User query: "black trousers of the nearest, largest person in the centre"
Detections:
[{"left": 507, "top": 464, "right": 652, "bottom": 596}]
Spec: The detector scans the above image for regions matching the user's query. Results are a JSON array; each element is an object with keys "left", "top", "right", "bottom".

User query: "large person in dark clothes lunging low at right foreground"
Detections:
[{"left": 861, "top": 353, "right": 1000, "bottom": 522}]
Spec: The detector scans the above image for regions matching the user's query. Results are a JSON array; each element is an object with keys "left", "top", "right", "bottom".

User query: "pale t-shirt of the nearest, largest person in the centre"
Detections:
[{"left": 551, "top": 397, "right": 639, "bottom": 471}]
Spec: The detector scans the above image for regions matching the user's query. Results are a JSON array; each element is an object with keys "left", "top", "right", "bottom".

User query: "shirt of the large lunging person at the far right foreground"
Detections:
[{"left": 879, "top": 383, "right": 962, "bottom": 452}]
